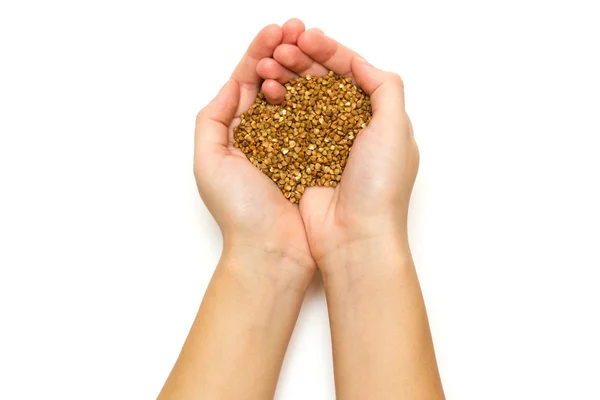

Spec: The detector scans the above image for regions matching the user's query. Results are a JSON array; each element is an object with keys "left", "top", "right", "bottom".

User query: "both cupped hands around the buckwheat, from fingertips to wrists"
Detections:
[{"left": 194, "top": 19, "right": 419, "bottom": 282}]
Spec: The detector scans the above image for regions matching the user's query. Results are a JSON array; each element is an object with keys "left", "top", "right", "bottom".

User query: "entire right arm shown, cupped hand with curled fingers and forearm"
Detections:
[{"left": 260, "top": 22, "right": 444, "bottom": 400}]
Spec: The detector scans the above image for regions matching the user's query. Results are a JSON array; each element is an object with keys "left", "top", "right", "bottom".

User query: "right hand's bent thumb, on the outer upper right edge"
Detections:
[{"left": 352, "top": 57, "right": 405, "bottom": 121}]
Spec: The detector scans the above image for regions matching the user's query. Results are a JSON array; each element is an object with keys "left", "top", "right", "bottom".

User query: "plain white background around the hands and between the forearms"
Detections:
[{"left": 0, "top": 0, "right": 600, "bottom": 400}]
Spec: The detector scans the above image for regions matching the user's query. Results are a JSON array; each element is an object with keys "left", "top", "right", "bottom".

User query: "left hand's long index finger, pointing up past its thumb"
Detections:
[{"left": 231, "top": 25, "right": 283, "bottom": 115}]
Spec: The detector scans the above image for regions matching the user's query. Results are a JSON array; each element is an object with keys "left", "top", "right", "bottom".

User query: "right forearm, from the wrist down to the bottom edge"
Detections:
[{"left": 324, "top": 239, "right": 444, "bottom": 400}]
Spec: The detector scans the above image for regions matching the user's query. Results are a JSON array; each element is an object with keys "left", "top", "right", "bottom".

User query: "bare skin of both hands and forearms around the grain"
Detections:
[{"left": 159, "top": 19, "right": 444, "bottom": 400}]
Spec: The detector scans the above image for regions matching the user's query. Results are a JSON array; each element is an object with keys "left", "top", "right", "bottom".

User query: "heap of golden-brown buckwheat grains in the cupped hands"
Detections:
[{"left": 234, "top": 72, "right": 371, "bottom": 203}]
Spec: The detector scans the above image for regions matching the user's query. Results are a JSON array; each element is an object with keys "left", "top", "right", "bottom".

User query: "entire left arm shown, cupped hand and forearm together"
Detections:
[{"left": 158, "top": 25, "right": 316, "bottom": 400}]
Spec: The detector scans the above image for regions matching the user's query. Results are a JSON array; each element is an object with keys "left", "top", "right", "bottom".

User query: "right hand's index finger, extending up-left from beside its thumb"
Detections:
[{"left": 296, "top": 29, "right": 358, "bottom": 75}]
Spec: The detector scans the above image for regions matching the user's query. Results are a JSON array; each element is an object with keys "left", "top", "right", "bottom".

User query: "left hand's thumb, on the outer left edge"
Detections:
[{"left": 195, "top": 79, "right": 240, "bottom": 153}]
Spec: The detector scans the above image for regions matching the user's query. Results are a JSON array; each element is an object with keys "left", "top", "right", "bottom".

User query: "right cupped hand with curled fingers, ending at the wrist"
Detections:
[{"left": 257, "top": 22, "right": 419, "bottom": 274}]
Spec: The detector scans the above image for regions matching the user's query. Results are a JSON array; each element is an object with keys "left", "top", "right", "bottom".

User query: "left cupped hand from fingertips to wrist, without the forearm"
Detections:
[{"left": 194, "top": 25, "right": 315, "bottom": 281}]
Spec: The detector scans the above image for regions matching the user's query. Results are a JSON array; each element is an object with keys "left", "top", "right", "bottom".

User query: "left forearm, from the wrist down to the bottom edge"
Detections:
[{"left": 159, "top": 247, "right": 310, "bottom": 400}]
